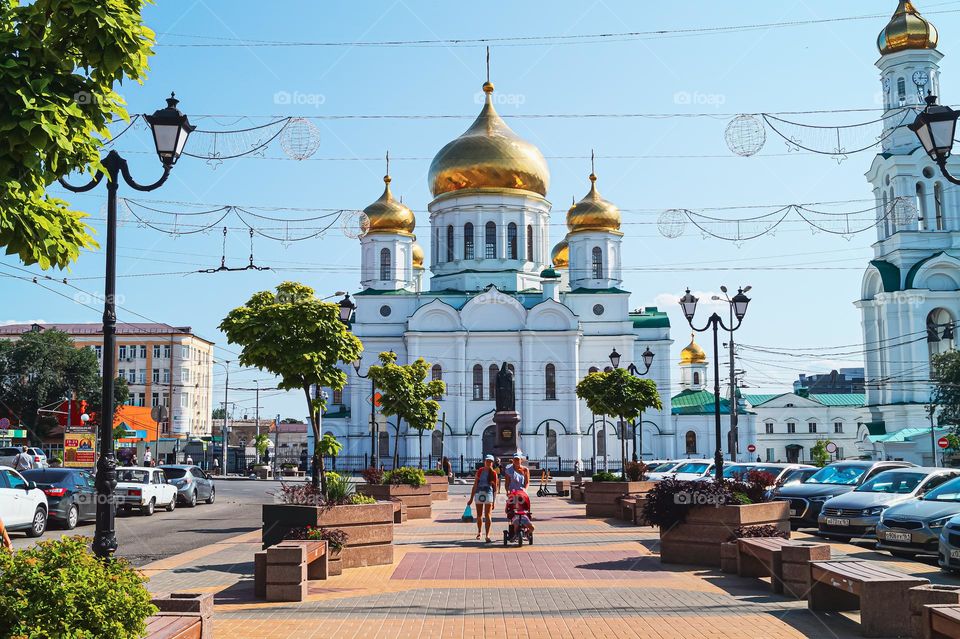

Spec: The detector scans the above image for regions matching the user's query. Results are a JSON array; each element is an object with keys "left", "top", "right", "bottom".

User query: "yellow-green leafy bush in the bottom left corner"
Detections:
[{"left": 0, "top": 537, "right": 157, "bottom": 639}]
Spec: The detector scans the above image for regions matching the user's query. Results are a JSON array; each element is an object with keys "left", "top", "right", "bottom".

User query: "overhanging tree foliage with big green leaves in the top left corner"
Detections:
[{"left": 0, "top": 0, "right": 154, "bottom": 269}]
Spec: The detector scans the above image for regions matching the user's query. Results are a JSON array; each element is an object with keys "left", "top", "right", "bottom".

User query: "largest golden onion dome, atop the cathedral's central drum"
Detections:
[{"left": 428, "top": 82, "right": 550, "bottom": 197}]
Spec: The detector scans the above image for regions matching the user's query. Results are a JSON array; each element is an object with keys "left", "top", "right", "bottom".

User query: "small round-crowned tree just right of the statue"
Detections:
[{"left": 577, "top": 368, "right": 663, "bottom": 478}]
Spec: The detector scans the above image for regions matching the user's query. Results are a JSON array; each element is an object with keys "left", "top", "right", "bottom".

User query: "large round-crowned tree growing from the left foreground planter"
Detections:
[{"left": 220, "top": 282, "right": 363, "bottom": 494}]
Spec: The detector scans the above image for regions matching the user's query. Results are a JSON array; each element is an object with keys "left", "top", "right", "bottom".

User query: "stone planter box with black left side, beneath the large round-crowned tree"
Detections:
[{"left": 262, "top": 503, "right": 393, "bottom": 568}]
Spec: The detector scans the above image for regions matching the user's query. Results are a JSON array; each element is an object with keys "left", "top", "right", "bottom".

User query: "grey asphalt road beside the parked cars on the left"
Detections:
[{"left": 10, "top": 481, "right": 280, "bottom": 566}]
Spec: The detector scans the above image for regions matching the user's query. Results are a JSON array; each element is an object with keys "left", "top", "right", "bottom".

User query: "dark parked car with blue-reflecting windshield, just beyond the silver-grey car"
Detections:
[{"left": 773, "top": 460, "right": 916, "bottom": 529}]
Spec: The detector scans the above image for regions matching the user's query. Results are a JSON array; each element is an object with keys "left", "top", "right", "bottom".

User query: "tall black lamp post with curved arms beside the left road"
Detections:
[{"left": 60, "top": 93, "right": 196, "bottom": 559}]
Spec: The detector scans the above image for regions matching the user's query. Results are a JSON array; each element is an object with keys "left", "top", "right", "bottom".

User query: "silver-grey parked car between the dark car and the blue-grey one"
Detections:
[{"left": 818, "top": 467, "right": 960, "bottom": 539}]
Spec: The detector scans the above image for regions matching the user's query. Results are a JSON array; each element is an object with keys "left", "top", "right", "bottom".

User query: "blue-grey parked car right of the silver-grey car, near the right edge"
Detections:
[{"left": 877, "top": 478, "right": 960, "bottom": 557}]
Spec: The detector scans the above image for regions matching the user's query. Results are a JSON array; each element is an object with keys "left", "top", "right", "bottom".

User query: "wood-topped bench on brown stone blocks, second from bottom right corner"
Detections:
[{"left": 807, "top": 561, "right": 930, "bottom": 637}]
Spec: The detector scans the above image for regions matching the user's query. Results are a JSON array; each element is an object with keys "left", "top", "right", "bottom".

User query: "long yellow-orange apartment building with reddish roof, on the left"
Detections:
[{"left": 0, "top": 322, "right": 213, "bottom": 437}]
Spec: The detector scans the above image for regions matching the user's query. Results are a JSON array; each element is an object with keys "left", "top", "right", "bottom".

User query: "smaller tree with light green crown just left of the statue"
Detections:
[{"left": 367, "top": 351, "right": 447, "bottom": 468}]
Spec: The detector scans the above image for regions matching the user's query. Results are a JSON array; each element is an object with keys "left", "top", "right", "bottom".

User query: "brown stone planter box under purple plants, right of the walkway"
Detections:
[{"left": 660, "top": 501, "right": 790, "bottom": 566}]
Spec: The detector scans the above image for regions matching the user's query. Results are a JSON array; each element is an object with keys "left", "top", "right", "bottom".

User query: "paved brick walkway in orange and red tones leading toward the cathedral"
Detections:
[{"left": 144, "top": 494, "right": 956, "bottom": 639}]
